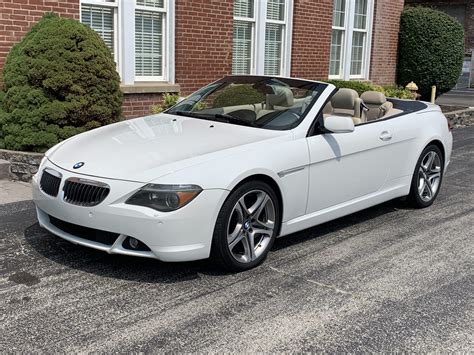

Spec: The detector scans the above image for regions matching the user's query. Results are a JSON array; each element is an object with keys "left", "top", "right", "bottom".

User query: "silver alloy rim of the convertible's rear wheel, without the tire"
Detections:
[{"left": 418, "top": 151, "right": 441, "bottom": 202}]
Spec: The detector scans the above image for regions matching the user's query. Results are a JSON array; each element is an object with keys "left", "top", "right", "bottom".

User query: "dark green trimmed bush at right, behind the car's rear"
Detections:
[{"left": 397, "top": 7, "right": 464, "bottom": 100}]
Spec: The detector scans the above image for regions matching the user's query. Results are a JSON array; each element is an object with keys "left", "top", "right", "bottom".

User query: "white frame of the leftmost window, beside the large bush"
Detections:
[{"left": 79, "top": 0, "right": 175, "bottom": 85}]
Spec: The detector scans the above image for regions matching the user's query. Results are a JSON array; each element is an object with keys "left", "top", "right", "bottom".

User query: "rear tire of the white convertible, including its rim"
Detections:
[{"left": 407, "top": 145, "right": 444, "bottom": 208}]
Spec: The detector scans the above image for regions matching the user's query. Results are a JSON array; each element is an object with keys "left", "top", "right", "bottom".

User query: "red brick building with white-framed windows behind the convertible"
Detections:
[{"left": 0, "top": 0, "right": 404, "bottom": 117}]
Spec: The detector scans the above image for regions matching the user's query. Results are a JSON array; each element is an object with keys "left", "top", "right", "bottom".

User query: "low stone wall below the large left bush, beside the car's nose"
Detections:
[{"left": 0, "top": 149, "right": 44, "bottom": 182}]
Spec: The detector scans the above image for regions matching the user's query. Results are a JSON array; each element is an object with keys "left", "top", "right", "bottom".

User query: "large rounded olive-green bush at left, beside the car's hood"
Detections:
[{"left": 0, "top": 14, "right": 122, "bottom": 152}]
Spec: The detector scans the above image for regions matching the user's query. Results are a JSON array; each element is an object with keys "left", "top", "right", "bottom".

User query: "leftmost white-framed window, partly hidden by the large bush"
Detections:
[{"left": 81, "top": 0, "right": 175, "bottom": 84}]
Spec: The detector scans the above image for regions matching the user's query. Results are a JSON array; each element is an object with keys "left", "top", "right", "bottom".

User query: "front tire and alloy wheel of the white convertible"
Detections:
[{"left": 211, "top": 181, "right": 280, "bottom": 272}]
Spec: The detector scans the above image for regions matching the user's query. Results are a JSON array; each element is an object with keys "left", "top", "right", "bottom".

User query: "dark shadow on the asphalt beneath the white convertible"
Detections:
[{"left": 24, "top": 201, "right": 403, "bottom": 283}]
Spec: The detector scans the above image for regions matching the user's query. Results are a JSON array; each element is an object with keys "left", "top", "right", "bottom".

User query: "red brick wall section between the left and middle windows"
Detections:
[{"left": 175, "top": 0, "right": 233, "bottom": 94}]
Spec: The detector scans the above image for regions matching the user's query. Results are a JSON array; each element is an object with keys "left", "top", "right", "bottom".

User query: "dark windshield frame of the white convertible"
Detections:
[{"left": 164, "top": 75, "right": 329, "bottom": 131}]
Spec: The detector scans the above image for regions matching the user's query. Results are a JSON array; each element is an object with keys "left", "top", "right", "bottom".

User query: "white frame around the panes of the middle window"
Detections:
[{"left": 234, "top": 0, "right": 294, "bottom": 76}]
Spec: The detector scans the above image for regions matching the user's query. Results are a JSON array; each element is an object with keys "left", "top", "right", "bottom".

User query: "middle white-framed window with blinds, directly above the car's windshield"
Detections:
[{"left": 232, "top": 0, "right": 293, "bottom": 75}]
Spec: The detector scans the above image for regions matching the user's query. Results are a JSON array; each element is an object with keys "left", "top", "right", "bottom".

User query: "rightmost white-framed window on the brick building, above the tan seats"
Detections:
[{"left": 329, "top": 0, "right": 373, "bottom": 80}]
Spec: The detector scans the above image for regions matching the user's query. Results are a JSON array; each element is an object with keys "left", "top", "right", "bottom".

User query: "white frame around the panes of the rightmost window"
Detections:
[{"left": 328, "top": 0, "right": 374, "bottom": 80}]
